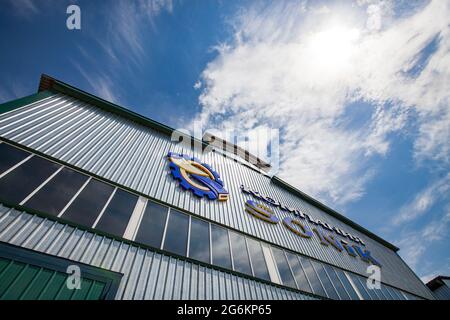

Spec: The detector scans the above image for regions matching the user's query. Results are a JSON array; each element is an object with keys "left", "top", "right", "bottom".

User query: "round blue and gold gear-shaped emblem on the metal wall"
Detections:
[{"left": 167, "top": 152, "right": 228, "bottom": 201}]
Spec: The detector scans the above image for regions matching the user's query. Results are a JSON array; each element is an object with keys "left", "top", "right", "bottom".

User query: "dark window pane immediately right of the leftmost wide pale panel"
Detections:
[{"left": 135, "top": 201, "right": 168, "bottom": 249}]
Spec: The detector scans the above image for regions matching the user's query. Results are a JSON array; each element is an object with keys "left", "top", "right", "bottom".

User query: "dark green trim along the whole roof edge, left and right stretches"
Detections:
[{"left": 0, "top": 74, "right": 399, "bottom": 252}]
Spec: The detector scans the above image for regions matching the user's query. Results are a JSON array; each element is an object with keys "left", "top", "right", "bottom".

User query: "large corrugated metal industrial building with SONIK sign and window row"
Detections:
[{"left": 0, "top": 75, "right": 434, "bottom": 300}]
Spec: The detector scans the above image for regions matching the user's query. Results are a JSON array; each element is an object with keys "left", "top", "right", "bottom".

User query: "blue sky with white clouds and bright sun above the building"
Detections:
[{"left": 0, "top": 0, "right": 450, "bottom": 280}]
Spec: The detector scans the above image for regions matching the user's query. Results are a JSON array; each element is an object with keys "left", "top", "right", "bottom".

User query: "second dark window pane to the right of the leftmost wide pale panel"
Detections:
[{"left": 164, "top": 209, "right": 189, "bottom": 256}]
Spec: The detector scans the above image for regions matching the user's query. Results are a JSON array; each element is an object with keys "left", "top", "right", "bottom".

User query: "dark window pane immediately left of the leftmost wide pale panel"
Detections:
[{"left": 95, "top": 189, "right": 138, "bottom": 236}]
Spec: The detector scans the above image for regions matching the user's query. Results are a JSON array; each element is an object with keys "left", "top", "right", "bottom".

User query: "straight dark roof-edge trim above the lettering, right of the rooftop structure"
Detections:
[{"left": 271, "top": 176, "right": 400, "bottom": 252}]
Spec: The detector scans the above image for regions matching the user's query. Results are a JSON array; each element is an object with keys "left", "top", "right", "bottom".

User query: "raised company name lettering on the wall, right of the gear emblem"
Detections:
[{"left": 241, "top": 186, "right": 381, "bottom": 267}]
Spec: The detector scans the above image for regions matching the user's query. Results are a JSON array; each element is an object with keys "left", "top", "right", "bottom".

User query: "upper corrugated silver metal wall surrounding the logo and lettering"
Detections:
[{"left": 0, "top": 94, "right": 432, "bottom": 298}]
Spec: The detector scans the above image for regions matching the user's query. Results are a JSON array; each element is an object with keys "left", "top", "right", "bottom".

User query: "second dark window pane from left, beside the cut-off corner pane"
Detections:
[{"left": 0, "top": 156, "right": 59, "bottom": 203}]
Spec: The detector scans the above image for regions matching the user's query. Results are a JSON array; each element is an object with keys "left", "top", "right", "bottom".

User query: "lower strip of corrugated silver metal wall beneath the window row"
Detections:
[{"left": 0, "top": 205, "right": 313, "bottom": 300}]
